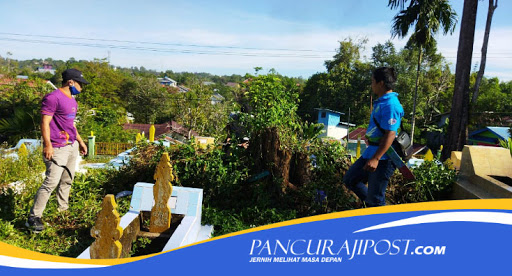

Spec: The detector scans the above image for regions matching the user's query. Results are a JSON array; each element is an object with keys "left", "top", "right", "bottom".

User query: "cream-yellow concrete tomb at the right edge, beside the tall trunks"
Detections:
[{"left": 453, "top": 146, "right": 512, "bottom": 199}]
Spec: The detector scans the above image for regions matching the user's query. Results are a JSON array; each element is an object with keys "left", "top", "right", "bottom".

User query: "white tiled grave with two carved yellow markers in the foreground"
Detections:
[{"left": 78, "top": 153, "right": 213, "bottom": 259}]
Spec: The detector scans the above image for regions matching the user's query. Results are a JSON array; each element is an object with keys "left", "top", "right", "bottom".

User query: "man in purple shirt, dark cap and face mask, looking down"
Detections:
[{"left": 26, "top": 69, "right": 89, "bottom": 232}]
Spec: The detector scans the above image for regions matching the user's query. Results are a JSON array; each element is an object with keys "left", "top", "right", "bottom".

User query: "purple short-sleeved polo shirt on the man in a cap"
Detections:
[{"left": 41, "top": 89, "right": 78, "bottom": 148}]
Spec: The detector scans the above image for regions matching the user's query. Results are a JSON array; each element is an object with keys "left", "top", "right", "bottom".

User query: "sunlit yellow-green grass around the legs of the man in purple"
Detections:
[{"left": 0, "top": 151, "right": 131, "bottom": 257}]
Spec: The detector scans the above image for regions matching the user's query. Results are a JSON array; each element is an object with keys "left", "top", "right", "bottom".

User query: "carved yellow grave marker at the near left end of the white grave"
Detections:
[{"left": 90, "top": 195, "right": 123, "bottom": 259}]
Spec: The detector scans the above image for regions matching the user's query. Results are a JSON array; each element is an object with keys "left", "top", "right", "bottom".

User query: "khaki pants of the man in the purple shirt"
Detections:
[{"left": 30, "top": 141, "right": 78, "bottom": 217}]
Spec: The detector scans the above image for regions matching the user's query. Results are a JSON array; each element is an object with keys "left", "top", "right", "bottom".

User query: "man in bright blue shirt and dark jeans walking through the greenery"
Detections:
[{"left": 343, "top": 67, "right": 404, "bottom": 207}]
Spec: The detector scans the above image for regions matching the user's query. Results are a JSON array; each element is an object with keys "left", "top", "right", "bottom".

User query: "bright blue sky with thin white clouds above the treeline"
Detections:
[{"left": 0, "top": 0, "right": 512, "bottom": 81}]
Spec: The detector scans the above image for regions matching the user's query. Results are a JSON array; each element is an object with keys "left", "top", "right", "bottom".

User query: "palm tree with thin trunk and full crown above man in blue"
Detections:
[{"left": 388, "top": 0, "right": 457, "bottom": 144}]
